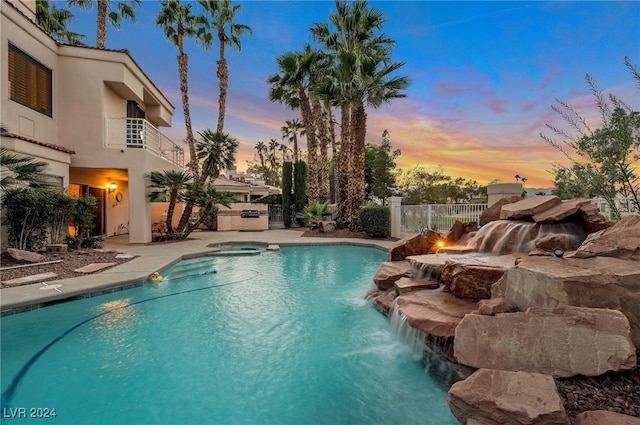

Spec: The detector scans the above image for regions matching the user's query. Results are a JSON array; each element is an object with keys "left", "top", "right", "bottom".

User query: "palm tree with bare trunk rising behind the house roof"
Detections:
[{"left": 67, "top": 0, "right": 142, "bottom": 49}]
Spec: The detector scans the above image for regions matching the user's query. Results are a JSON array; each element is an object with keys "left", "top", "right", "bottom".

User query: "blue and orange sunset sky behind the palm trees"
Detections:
[{"left": 66, "top": 1, "right": 640, "bottom": 188}]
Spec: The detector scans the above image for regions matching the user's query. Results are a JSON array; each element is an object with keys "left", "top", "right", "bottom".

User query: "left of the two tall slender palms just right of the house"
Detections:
[{"left": 156, "top": 0, "right": 204, "bottom": 178}]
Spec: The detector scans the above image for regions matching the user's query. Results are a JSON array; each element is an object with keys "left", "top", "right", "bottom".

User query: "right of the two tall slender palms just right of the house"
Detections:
[{"left": 199, "top": 0, "right": 253, "bottom": 133}]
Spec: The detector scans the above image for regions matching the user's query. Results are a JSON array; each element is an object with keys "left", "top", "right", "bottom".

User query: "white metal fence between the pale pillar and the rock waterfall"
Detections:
[{"left": 400, "top": 204, "right": 487, "bottom": 233}]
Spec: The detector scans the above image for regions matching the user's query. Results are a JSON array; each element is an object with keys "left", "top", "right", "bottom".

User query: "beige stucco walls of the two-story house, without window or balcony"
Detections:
[{"left": 0, "top": 0, "right": 179, "bottom": 243}]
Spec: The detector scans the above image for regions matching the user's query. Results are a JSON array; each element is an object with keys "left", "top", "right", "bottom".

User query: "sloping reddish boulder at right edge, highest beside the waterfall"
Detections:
[{"left": 573, "top": 214, "right": 640, "bottom": 261}]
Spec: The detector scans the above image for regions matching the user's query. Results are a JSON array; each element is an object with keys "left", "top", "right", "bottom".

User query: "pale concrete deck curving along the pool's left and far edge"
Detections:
[{"left": 0, "top": 229, "right": 393, "bottom": 316}]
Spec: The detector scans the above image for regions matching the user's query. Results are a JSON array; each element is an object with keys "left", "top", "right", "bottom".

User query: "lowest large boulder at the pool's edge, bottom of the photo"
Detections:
[{"left": 448, "top": 369, "right": 571, "bottom": 425}]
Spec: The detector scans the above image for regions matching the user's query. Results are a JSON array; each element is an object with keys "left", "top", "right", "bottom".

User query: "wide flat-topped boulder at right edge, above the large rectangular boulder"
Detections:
[{"left": 498, "top": 257, "right": 640, "bottom": 347}]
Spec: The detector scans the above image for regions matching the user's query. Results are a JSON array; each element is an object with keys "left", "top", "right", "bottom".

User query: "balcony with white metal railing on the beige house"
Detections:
[{"left": 105, "top": 117, "right": 184, "bottom": 168}]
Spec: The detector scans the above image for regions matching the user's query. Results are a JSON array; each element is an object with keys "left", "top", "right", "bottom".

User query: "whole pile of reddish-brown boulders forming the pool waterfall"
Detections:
[{"left": 364, "top": 196, "right": 640, "bottom": 424}]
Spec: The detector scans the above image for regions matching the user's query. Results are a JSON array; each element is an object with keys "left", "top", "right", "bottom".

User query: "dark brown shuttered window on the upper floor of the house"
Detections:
[{"left": 9, "top": 44, "right": 53, "bottom": 117}]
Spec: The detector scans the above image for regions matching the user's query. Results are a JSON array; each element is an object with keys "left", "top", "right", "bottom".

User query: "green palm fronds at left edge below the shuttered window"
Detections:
[{"left": 0, "top": 147, "right": 52, "bottom": 191}]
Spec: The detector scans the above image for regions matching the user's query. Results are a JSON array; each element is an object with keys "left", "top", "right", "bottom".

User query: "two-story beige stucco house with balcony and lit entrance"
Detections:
[{"left": 0, "top": 0, "right": 184, "bottom": 243}]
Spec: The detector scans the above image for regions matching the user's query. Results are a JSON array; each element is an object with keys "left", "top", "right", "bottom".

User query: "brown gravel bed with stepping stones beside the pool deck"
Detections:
[{"left": 0, "top": 249, "right": 136, "bottom": 288}]
